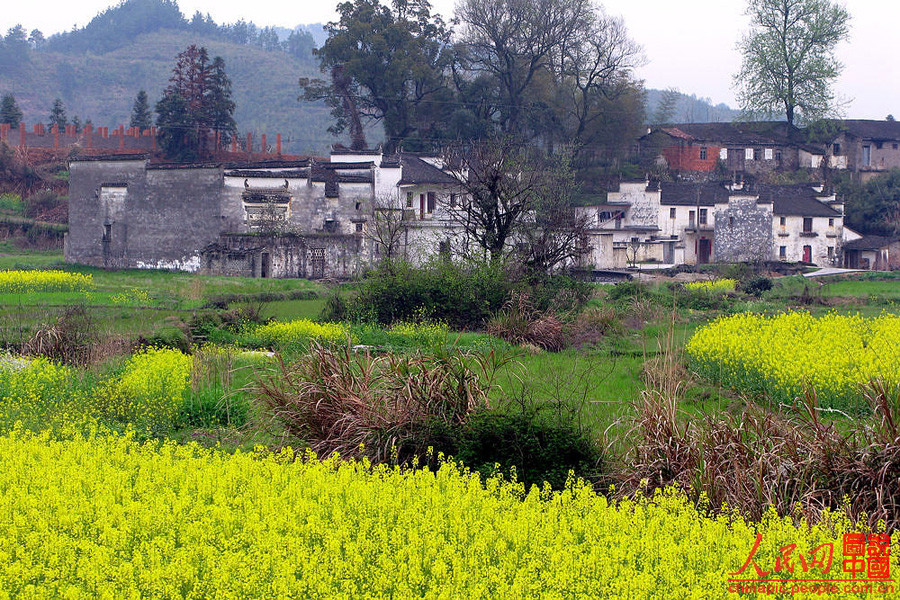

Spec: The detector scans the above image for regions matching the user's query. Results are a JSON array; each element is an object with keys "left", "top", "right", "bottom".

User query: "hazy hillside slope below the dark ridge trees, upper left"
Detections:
[{"left": 0, "top": 29, "right": 335, "bottom": 154}]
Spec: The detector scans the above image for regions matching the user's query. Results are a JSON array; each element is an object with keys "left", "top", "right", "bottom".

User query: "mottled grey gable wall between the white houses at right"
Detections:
[{"left": 713, "top": 195, "right": 773, "bottom": 262}]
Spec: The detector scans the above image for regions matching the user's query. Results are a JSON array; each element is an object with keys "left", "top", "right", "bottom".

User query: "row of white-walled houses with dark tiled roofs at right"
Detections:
[{"left": 579, "top": 181, "right": 860, "bottom": 269}]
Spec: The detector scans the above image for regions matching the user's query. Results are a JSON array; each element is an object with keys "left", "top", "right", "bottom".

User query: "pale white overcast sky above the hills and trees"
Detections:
[{"left": 0, "top": 0, "right": 900, "bottom": 119}]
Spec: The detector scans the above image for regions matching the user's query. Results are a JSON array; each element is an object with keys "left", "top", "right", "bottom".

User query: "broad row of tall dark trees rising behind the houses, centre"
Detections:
[{"left": 300, "top": 0, "right": 645, "bottom": 163}]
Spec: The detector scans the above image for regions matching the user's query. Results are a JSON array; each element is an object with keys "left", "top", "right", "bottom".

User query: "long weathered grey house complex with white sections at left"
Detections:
[{"left": 65, "top": 150, "right": 464, "bottom": 278}]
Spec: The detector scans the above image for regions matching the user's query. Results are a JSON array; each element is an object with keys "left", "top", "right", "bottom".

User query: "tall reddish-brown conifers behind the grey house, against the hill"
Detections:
[{"left": 156, "top": 45, "right": 236, "bottom": 161}]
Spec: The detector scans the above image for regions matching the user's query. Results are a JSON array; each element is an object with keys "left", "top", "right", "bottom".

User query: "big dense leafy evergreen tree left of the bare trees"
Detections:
[{"left": 300, "top": 0, "right": 450, "bottom": 152}]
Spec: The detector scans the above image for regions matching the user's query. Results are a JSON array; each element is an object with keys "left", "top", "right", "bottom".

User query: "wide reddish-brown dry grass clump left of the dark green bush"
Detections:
[{"left": 254, "top": 342, "right": 503, "bottom": 463}]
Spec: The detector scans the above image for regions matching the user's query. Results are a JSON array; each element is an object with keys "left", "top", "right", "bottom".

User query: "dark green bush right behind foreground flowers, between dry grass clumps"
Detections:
[{"left": 456, "top": 409, "right": 601, "bottom": 490}]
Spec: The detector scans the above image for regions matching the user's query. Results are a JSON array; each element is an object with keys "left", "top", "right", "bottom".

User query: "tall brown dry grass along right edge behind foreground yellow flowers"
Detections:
[{"left": 618, "top": 356, "right": 900, "bottom": 529}]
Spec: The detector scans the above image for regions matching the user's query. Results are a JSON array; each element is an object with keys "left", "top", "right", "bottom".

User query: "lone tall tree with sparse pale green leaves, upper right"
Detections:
[{"left": 735, "top": 0, "right": 850, "bottom": 125}]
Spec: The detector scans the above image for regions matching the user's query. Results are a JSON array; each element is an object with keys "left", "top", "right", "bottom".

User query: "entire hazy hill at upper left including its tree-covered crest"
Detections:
[{"left": 0, "top": 0, "right": 335, "bottom": 154}]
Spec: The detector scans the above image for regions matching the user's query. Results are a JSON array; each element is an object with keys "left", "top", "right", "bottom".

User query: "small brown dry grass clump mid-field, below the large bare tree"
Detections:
[{"left": 487, "top": 292, "right": 565, "bottom": 352}]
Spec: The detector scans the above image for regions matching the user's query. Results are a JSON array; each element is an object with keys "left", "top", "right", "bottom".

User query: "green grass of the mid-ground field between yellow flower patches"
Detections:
[{"left": 0, "top": 250, "right": 900, "bottom": 446}]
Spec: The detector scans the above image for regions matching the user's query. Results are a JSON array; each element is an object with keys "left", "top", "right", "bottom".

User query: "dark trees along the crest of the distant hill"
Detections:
[{"left": 10, "top": 0, "right": 315, "bottom": 62}]
